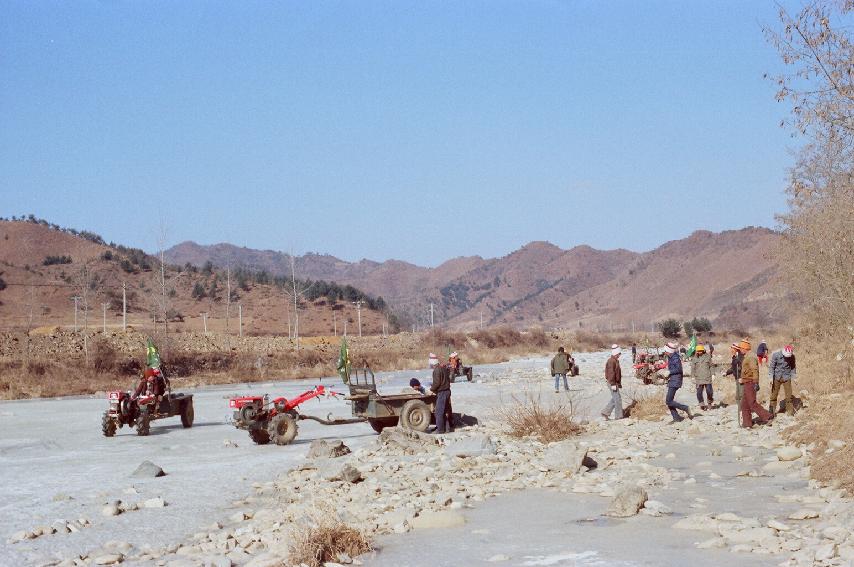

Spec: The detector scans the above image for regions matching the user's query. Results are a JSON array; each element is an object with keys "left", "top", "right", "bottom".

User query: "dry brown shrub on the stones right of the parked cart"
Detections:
[{"left": 498, "top": 394, "right": 583, "bottom": 443}]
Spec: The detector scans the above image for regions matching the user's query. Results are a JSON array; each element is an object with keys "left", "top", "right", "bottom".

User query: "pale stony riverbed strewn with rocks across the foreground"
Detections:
[{"left": 0, "top": 354, "right": 854, "bottom": 567}]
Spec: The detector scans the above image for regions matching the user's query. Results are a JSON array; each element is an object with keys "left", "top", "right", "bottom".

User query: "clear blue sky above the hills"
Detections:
[{"left": 0, "top": 0, "right": 797, "bottom": 265}]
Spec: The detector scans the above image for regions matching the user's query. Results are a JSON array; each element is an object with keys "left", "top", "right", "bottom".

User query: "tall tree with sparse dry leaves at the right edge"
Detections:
[{"left": 765, "top": 0, "right": 854, "bottom": 374}]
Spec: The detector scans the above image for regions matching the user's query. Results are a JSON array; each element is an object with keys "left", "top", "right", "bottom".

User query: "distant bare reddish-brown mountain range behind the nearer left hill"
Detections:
[{"left": 166, "top": 227, "right": 789, "bottom": 330}]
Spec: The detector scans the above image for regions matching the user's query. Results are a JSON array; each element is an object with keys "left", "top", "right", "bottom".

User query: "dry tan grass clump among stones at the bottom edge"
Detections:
[{"left": 288, "top": 514, "right": 373, "bottom": 567}]
